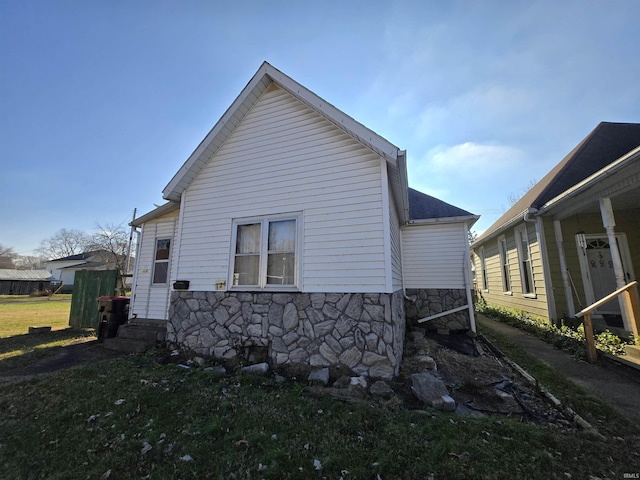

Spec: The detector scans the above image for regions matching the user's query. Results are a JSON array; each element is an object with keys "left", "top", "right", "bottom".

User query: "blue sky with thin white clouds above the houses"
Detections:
[{"left": 0, "top": 0, "right": 640, "bottom": 255}]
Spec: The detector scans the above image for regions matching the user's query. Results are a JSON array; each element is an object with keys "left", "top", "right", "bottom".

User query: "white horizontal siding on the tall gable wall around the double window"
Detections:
[{"left": 177, "top": 84, "right": 390, "bottom": 292}]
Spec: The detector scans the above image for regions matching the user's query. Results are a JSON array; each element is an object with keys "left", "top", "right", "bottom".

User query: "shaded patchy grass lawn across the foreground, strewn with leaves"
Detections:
[{"left": 0, "top": 355, "right": 640, "bottom": 480}]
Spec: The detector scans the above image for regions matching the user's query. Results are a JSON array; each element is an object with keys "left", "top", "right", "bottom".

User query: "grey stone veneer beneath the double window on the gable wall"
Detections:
[{"left": 167, "top": 291, "right": 405, "bottom": 379}]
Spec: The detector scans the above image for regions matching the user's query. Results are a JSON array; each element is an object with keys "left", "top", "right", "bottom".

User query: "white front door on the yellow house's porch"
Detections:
[{"left": 576, "top": 233, "right": 635, "bottom": 315}]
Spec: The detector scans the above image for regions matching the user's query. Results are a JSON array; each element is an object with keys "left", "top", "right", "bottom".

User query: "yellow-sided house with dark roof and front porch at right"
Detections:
[{"left": 472, "top": 122, "right": 640, "bottom": 333}]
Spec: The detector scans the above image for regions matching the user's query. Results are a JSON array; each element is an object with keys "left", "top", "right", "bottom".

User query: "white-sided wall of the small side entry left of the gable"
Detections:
[{"left": 130, "top": 211, "right": 178, "bottom": 320}]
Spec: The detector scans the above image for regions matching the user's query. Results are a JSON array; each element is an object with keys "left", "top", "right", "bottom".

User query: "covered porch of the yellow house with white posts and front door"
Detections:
[{"left": 536, "top": 148, "right": 640, "bottom": 335}]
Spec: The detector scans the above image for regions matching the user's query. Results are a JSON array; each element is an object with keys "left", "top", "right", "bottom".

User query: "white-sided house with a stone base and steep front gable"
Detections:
[{"left": 130, "top": 62, "right": 478, "bottom": 378}]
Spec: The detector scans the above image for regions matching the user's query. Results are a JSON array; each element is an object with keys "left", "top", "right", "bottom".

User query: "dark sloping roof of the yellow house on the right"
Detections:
[{"left": 476, "top": 122, "right": 640, "bottom": 242}]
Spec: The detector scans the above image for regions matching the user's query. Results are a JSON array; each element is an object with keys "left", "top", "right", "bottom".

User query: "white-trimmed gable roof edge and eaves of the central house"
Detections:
[{"left": 162, "top": 62, "right": 409, "bottom": 221}]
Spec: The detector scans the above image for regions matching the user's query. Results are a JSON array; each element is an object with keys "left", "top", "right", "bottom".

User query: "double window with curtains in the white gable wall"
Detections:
[{"left": 231, "top": 215, "right": 300, "bottom": 289}]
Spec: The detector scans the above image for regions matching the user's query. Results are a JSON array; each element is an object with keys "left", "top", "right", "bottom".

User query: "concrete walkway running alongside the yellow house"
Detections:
[{"left": 476, "top": 315, "right": 640, "bottom": 425}]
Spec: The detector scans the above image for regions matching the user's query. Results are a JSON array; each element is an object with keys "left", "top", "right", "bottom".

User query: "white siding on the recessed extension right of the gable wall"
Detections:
[{"left": 402, "top": 223, "right": 467, "bottom": 288}]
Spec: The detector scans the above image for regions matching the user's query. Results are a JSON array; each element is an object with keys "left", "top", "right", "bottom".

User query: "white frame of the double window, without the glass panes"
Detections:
[{"left": 227, "top": 212, "right": 303, "bottom": 291}]
